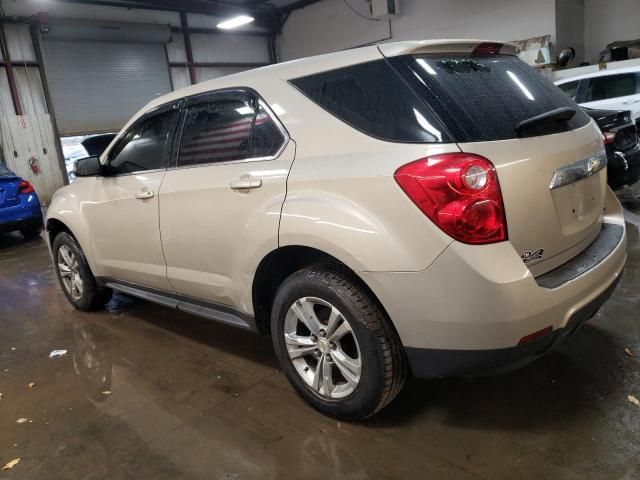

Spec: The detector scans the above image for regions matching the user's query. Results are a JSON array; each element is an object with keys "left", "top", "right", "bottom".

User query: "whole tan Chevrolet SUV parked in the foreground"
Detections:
[{"left": 46, "top": 40, "right": 626, "bottom": 419}]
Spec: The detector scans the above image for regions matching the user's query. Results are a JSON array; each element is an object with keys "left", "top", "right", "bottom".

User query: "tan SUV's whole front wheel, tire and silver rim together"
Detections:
[{"left": 51, "top": 232, "right": 111, "bottom": 312}]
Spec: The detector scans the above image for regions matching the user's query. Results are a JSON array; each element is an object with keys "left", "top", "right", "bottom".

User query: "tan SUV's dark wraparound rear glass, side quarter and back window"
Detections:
[{"left": 291, "top": 55, "right": 590, "bottom": 143}]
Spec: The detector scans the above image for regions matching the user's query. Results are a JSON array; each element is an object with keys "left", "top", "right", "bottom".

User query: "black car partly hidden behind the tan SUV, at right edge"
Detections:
[{"left": 584, "top": 108, "right": 640, "bottom": 190}]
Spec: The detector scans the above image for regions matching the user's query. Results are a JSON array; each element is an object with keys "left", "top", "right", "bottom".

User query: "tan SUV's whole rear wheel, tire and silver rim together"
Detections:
[{"left": 271, "top": 265, "right": 407, "bottom": 420}]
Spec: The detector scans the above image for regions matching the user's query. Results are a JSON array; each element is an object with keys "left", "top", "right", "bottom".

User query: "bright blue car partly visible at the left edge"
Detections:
[{"left": 0, "top": 165, "right": 42, "bottom": 238}]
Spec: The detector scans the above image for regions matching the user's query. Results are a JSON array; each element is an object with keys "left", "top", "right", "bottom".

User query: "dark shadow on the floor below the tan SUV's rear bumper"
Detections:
[{"left": 370, "top": 325, "right": 626, "bottom": 431}]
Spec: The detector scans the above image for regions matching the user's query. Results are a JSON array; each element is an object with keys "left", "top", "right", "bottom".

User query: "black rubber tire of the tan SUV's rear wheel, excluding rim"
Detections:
[{"left": 271, "top": 264, "right": 407, "bottom": 420}]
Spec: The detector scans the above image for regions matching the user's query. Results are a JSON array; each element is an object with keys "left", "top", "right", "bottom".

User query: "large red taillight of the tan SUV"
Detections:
[{"left": 394, "top": 153, "right": 507, "bottom": 245}]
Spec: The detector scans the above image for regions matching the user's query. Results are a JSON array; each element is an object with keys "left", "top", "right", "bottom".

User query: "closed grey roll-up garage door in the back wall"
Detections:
[{"left": 42, "top": 22, "right": 171, "bottom": 136}]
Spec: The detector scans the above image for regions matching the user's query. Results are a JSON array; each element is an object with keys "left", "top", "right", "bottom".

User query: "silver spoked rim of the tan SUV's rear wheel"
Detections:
[{"left": 284, "top": 297, "right": 362, "bottom": 399}]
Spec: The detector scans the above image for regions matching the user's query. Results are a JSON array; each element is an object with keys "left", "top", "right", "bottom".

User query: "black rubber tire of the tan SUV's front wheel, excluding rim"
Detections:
[{"left": 51, "top": 232, "right": 111, "bottom": 312}]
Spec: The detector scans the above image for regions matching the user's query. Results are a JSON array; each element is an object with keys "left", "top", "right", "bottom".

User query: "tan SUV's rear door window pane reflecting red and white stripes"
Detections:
[{"left": 178, "top": 99, "right": 255, "bottom": 166}]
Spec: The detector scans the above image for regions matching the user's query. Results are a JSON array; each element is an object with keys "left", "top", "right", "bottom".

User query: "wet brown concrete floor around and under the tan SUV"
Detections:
[{"left": 0, "top": 199, "right": 640, "bottom": 480}]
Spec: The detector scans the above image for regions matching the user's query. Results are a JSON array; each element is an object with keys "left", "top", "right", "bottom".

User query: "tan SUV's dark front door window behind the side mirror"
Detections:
[{"left": 108, "top": 110, "right": 179, "bottom": 175}]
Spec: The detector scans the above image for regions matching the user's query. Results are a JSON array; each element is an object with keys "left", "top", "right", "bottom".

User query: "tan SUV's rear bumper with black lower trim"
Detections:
[{"left": 359, "top": 190, "right": 627, "bottom": 377}]
